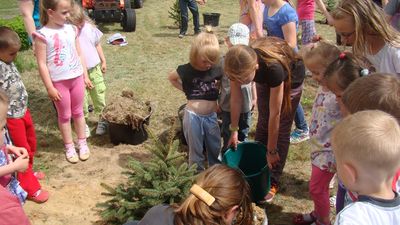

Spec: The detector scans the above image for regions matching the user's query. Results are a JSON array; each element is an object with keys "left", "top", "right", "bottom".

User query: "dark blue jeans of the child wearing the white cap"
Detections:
[{"left": 221, "top": 111, "right": 252, "bottom": 151}]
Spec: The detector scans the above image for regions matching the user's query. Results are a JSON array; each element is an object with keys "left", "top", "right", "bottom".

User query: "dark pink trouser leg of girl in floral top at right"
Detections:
[{"left": 310, "top": 165, "right": 335, "bottom": 224}]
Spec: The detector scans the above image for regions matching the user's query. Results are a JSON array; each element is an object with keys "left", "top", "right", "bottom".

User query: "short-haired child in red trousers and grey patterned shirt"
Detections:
[{"left": 0, "top": 27, "right": 49, "bottom": 203}]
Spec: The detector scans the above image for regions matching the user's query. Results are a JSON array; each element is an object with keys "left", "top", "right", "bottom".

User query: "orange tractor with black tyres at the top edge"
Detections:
[{"left": 81, "top": 0, "right": 143, "bottom": 32}]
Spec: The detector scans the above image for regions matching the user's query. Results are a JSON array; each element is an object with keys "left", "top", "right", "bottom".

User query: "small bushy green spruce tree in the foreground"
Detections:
[{"left": 97, "top": 129, "right": 196, "bottom": 224}]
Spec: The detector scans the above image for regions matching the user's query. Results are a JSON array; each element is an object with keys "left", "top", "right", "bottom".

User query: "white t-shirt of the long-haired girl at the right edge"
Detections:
[{"left": 367, "top": 43, "right": 400, "bottom": 77}]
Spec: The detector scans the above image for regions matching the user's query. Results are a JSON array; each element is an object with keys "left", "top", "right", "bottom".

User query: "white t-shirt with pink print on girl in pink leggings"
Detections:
[{"left": 33, "top": 24, "right": 83, "bottom": 82}]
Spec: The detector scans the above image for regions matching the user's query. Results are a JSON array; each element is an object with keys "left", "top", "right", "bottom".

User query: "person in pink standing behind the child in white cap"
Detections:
[{"left": 239, "top": 0, "right": 264, "bottom": 39}]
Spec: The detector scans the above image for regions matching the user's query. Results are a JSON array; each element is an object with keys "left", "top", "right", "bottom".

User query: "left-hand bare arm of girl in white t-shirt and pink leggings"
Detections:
[{"left": 35, "top": 38, "right": 62, "bottom": 101}]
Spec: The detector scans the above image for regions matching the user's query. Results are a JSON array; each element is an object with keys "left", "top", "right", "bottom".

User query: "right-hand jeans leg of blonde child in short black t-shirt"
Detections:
[{"left": 202, "top": 113, "right": 221, "bottom": 166}]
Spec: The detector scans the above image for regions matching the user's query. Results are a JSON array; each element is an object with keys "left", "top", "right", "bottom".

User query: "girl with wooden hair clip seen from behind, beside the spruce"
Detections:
[{"left": 125, "top": 165, "right": 253, "bottom": 225}]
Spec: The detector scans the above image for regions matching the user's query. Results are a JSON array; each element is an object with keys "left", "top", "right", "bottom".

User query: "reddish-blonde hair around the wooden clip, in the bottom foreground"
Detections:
[{"left": 173, "top": 164, "right": 253, "bottom": 225}]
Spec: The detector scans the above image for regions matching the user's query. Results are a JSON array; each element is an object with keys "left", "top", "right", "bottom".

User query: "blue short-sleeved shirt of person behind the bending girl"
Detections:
[{"left": 263, "top": 3, "right": 299, "bottom": 39}]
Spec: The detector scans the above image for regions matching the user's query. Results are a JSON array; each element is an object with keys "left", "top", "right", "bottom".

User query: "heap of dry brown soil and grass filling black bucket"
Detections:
[{"left": 102, "top": 90, "right": 151, "bottom": 130}]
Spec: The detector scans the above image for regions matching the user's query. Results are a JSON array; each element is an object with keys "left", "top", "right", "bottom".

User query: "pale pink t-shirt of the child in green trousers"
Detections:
[{"left": 79, "top": 22, "right": 103, "bottom": 69}]
